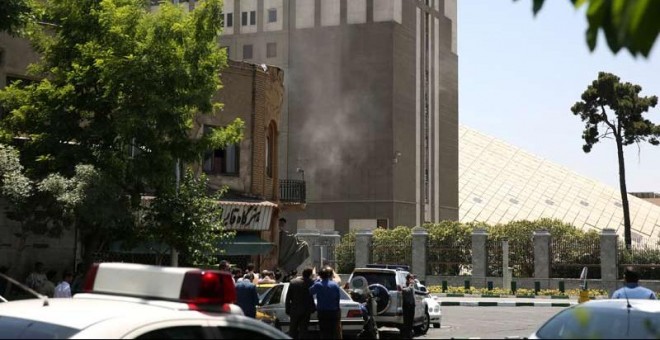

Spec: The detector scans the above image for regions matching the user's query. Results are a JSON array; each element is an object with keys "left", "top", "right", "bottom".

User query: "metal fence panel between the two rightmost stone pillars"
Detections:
[{"left": 550, "top": 238, "right": 601, "bottom": 279}]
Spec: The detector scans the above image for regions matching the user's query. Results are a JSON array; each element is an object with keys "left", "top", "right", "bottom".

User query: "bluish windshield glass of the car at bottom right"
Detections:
[{"left": 536, "top": 306, "right": 660, "bottom": 339}]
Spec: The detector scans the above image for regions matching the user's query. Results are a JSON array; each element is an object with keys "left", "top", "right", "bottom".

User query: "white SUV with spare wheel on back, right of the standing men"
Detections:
[{"left": 345, "top": 264, "right": 431, "bottom": 334}]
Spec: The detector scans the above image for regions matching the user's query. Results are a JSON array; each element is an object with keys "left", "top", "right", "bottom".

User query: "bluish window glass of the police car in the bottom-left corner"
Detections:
[{"left": 0, "top": 316, "right": 80, "bottom": 339}]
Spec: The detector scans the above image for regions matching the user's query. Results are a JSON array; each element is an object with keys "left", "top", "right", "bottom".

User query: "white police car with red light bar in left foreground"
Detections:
[{"left": 0, "top": 263, "right": 289, "bottom": 339}]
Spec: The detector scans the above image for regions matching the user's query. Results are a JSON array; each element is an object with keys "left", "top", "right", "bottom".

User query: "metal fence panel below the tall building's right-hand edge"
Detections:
[{"left": 426, "top": 238, "right": 472, "bottom": 276}]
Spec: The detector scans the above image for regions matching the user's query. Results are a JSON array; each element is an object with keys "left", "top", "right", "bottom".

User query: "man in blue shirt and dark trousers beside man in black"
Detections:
[{"left": 309, "top": 266, "right": 341, "bottom": 339}]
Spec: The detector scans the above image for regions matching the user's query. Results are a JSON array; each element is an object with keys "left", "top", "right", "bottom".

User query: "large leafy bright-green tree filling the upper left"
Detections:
[{"left": 0, "top": 0, "right": 243, "bottom": 266}]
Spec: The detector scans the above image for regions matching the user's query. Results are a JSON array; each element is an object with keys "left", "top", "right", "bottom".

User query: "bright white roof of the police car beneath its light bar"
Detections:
[{"left": 0, "top": 294, "right": 207, "bottom": 329}]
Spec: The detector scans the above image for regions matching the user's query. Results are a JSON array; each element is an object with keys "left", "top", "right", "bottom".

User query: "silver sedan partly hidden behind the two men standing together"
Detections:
[{"left": 257, "top": 282, "right": 364, "bottom": 337}]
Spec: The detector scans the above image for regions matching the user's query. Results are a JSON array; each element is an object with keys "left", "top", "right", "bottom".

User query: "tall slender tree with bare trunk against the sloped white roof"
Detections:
[{"left": 571, "top": 72, "right": 660, "bottom": 249}]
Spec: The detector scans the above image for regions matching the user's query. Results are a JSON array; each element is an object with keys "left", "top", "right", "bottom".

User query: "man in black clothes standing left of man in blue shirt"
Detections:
[{"left": 284, "top": 267, "right": 316, "bottom": 339}]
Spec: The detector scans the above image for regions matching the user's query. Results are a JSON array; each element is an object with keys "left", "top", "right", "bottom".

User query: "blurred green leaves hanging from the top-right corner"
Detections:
[{"left": 514, "top": 0, "right": 660, "bottom": 57}]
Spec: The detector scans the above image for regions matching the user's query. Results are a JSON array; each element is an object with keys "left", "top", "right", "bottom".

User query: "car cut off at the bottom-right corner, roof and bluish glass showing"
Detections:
[{"left": 529, "top": 299, "right": 660, "bottom": 339}]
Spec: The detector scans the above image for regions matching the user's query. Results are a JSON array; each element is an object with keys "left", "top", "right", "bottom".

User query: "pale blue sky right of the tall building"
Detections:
[{"left": 457, "top": 0, "right": 660, "bottom": 193}]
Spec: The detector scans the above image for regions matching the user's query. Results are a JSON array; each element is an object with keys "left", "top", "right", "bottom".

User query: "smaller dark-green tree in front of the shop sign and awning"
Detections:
[{"left": 138, "top": 170, "right": 234, "bottom": 265}]
